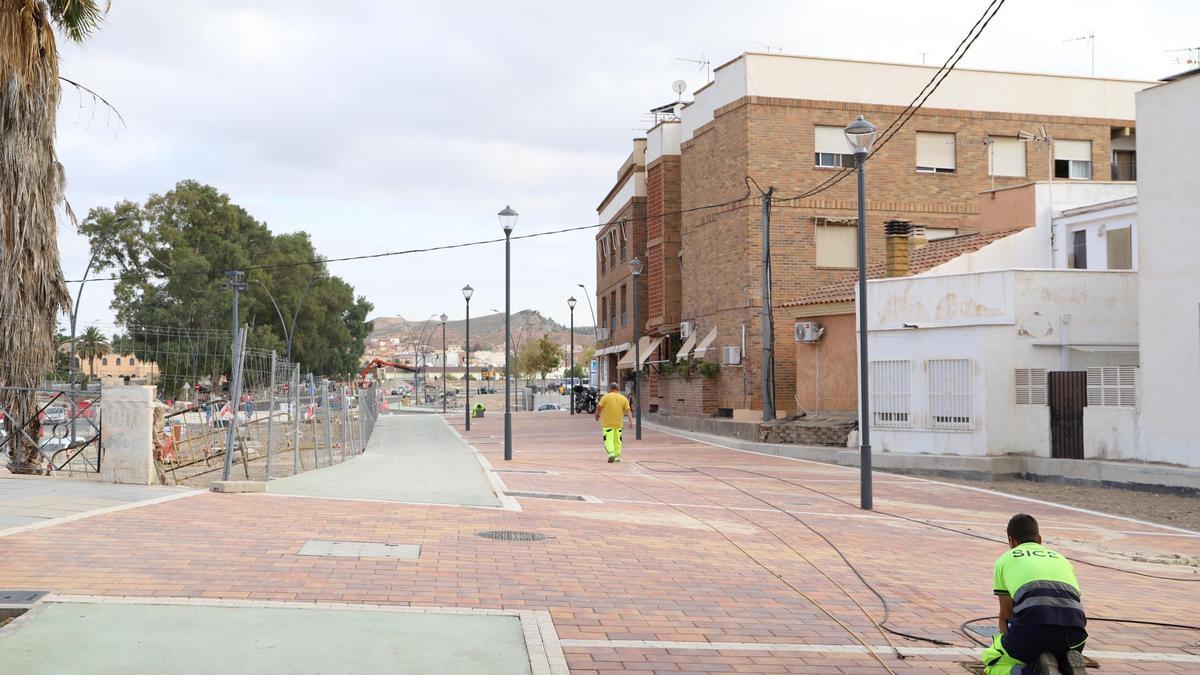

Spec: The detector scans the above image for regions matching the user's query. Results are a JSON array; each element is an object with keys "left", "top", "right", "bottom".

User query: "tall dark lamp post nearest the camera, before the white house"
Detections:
[{"left": 846, "top": 115, "right": 875, "bottom": 510}]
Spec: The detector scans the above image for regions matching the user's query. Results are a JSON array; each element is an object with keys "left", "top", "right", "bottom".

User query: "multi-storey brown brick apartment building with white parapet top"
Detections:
[{"left": 598, "top": 53, "right": 1151, "bottom": 417}]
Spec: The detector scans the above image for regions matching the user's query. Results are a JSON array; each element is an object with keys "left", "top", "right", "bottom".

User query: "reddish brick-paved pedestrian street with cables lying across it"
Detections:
[{"left": 0, "top": 413, "right": 1200, "bottom": 674}]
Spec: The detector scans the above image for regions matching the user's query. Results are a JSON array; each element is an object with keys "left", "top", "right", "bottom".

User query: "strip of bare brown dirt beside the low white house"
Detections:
[{"left": 938, "top": 478, "right": 1200, "bottom": 530}]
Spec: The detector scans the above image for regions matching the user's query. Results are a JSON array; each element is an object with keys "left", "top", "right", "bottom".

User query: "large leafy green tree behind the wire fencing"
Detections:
[{"left": 79, "top": 180, "right": 372, "bottom": 395}]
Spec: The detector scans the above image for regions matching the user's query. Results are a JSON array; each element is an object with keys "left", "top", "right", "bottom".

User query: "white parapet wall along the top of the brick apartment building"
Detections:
[{"left": 682, "top": 53, "right": 1153, "bottom": 141}]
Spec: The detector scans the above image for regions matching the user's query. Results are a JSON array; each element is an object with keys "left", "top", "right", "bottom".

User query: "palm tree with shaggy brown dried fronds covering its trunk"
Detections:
[{"left": 0, "top": 0, "right": 108, "bottom": 473}]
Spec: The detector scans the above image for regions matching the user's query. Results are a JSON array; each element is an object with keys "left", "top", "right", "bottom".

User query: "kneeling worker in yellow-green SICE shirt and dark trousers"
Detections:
[{"left": 982, "top": 513, "right": 1087, "bottom": 675}]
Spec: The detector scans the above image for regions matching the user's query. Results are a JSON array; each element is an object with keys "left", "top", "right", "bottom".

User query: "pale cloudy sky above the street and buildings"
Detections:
[{"left": 58, "top": 0, "right": 1200, "bottom": 325}]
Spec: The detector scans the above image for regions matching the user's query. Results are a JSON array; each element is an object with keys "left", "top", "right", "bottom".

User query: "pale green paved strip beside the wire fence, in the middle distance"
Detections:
[{"left": 266, "top": 414, "right": 500, "bottom": 507}]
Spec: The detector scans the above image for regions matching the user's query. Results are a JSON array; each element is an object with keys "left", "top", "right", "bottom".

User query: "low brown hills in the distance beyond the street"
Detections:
[{"left": 371, "top": 310, "right": 595, "bottom": 351}]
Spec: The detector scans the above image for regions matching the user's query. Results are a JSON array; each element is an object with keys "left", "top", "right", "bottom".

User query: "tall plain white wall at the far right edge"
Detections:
[{"left": 1138, "top": 76, "right": 1200, "bottom": 466}]
